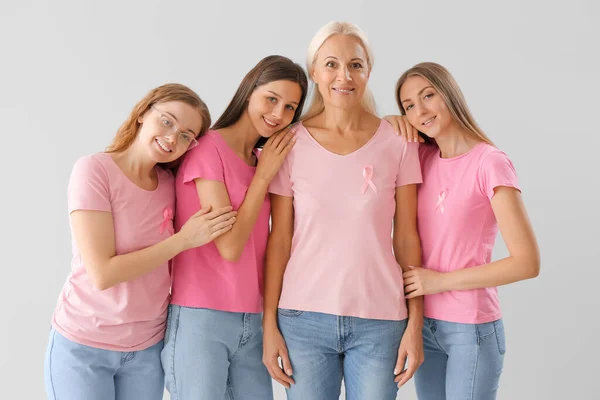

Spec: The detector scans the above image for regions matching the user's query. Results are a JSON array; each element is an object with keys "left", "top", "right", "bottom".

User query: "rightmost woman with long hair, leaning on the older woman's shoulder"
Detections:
[{"left": 386, "top": 63, "right": 540, "bottom": 400}]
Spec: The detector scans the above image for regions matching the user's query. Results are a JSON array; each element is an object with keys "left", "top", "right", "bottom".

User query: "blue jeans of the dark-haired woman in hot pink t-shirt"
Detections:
[{"left": 161, "top": 304, "right": 273, "bottom": 400}]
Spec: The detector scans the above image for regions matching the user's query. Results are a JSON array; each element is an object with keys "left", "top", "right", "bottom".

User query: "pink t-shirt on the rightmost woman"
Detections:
[{"left": 418, "top": 142, "right": 519, "bottom": 324}]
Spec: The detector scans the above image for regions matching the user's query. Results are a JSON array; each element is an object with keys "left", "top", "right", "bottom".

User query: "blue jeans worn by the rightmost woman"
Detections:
[{"left": 415, "top": 318, "right": 506, "bottom": 400}]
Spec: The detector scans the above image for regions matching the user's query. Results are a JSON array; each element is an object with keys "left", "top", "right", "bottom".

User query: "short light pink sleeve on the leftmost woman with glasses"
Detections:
[{"left": 67, "top": 156, "right": 112, "bottom": 214}]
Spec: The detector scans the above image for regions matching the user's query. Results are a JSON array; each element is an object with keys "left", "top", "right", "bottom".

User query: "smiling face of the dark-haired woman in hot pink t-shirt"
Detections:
[{"left": 246, "top": 80, "right": 302, "bottom": 138}]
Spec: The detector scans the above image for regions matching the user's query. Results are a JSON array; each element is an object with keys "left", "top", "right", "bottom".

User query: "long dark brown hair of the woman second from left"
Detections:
[{"left": 211, "top": 55, "right": 308, "bottom": 147}]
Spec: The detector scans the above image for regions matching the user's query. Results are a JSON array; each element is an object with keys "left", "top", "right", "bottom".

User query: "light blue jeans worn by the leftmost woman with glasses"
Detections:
[{"left": 44, "top": 329, "right": 165, "bottom": 400}]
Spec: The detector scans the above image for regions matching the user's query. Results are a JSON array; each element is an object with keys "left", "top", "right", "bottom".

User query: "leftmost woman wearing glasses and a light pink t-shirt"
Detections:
[{"left": 45, "top": 84, "right": 235, "bottom": 400}]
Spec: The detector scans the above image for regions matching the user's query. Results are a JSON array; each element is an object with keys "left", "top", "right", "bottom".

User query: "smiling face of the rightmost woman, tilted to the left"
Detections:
[{"left": 400, "top": 75, "right": 455, "bottom": 139}]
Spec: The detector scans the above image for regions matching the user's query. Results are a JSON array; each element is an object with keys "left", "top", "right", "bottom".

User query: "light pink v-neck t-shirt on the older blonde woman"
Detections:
[{"left": 269, "top": 121, "right": 421, "bottom": 320}]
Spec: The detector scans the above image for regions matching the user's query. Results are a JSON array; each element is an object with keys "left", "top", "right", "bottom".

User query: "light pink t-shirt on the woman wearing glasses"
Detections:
[{"left": 52, "top": 153, "right": 175, "bottom": 351}]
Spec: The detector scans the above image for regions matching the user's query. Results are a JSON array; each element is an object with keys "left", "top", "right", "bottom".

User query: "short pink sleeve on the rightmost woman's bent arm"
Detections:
[{"left": 479, "top": 150, "right": 521, "bottom": 200}]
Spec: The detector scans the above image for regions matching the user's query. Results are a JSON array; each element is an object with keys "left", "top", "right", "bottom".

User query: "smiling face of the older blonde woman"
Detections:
[{"left": 312, "top": 35, "right": 370, "bottom": 109}]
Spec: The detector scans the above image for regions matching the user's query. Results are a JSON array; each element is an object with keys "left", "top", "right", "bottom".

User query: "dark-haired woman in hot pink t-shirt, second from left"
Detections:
[{"left": 162, "top": 56, "right": 307, "bottom": 400}]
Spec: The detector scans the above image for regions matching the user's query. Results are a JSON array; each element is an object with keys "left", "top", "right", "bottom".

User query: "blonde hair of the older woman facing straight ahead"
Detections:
[{"left": 302, "top": 21, "right": 377, "bottom": 120}]
